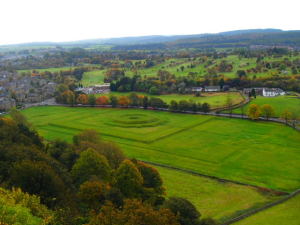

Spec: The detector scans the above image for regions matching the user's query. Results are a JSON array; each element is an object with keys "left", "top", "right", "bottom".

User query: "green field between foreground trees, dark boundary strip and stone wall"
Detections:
[{"left": 156, "top": 167, "right": 275, "bottom": 221}]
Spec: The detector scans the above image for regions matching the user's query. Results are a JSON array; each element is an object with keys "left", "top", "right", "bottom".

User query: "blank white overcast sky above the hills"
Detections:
[{"left": 0, "top": 0, "right": 300, "bottom": 45}]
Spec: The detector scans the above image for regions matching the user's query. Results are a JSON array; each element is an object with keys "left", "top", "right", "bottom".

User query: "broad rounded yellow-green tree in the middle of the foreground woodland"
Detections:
[{"left": 71, "top": 149, "right": 111, "bottom": 185}]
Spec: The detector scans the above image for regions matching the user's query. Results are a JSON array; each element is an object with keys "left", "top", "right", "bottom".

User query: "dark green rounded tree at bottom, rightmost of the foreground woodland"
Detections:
[{"left": 164, "top": 197, "right": 201, "bottom": 225}]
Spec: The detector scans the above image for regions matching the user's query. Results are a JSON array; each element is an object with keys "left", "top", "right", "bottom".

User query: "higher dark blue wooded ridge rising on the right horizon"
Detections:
[{"left": 113, "top": 29, "right": 300, "bottom": 50}]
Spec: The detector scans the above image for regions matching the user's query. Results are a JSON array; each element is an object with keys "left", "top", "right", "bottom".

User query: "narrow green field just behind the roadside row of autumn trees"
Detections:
[{"left": 97, "top": 92, "right": 244, "bottom": 108}]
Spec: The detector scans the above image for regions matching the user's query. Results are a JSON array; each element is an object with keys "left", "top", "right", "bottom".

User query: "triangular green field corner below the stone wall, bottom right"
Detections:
[{"left": 234, "top": 195, "right": 300, "bottom": 225}]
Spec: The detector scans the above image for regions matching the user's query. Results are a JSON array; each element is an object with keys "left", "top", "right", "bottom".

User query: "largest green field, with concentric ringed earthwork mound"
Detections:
[{"left": 24, "top": 107, "right": 300, "bottom": 191}]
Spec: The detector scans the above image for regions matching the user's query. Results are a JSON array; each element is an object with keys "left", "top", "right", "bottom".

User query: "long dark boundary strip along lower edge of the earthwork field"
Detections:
[{"left": 139, "top": 160, "right": 288, "bottom": 195}]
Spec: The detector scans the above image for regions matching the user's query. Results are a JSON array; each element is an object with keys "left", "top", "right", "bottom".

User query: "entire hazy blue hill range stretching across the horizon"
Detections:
[{"left": 0, "top": 29, "right": 300, "bottom": 50}]
